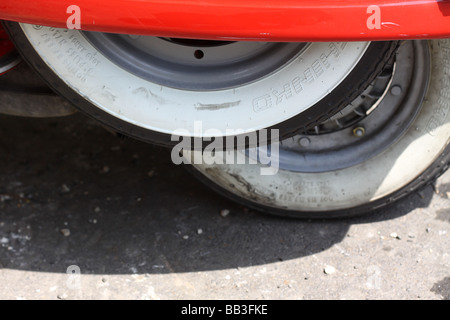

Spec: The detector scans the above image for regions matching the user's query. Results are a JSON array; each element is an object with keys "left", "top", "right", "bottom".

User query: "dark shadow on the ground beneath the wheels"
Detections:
[{"left": 0, "top": 114, "right": 433, "bottom": 274}]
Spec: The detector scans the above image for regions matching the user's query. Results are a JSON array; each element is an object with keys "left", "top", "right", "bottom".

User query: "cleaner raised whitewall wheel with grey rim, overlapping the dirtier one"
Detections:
[{"left": 4, "top": 22, "right": 396, "bottom": 146}]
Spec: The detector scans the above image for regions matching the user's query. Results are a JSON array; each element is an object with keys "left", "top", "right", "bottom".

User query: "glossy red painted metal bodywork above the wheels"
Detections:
[{"left": 0, "top": 0, "right": 450, "bottom": 41}]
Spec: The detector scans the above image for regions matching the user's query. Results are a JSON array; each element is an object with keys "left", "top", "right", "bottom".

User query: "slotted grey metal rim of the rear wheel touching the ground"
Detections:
[{"left": 268, "top": 41, "right": 430, "bottom": 172}]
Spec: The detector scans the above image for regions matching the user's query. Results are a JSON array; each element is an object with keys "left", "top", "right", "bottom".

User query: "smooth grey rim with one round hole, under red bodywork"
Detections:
[{"left": 84, "top": 32, "right": 307, "bottom": 91}]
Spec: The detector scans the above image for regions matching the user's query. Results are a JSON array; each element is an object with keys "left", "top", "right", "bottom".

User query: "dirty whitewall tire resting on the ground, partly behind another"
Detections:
[{"left": 188, "top": 40, "right": 450, "bottom": 218}]
